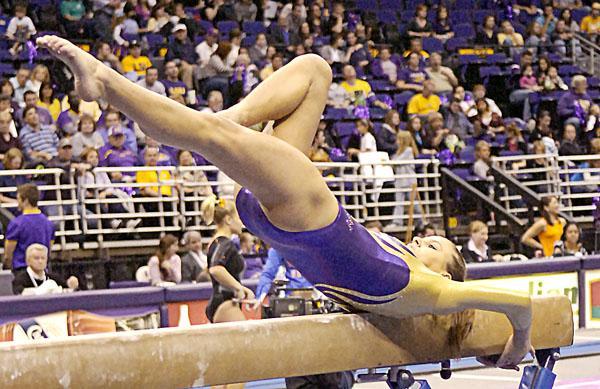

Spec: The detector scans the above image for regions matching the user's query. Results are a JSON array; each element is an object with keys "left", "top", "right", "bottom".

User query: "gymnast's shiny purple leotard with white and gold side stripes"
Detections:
[{"left": 236, "top": 189, "right": 414, "bottom": 306}]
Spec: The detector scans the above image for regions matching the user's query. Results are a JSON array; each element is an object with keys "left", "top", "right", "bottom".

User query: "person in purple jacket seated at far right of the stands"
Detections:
[{"left": 557, "top": 74, "right": 600, "bottom": 131}]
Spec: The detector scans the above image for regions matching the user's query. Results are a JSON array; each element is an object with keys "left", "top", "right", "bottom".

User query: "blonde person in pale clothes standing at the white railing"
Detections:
[{"left": 386, "top": 131, "right": 421, "bottom": 230}]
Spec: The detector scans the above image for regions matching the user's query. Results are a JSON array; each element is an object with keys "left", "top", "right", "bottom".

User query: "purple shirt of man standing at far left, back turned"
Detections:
[{"left": 6, "top": 211, "right": 54, "bottom": 270}]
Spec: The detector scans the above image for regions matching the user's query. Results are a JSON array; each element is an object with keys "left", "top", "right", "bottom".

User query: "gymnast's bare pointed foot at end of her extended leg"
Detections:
[{"left": 36, "top": 35, "right": 107, "bottom": 101}]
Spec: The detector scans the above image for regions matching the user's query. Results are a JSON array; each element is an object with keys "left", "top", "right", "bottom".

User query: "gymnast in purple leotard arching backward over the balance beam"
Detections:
[{"left": 37, "top": 36, "right": 532, "bottom": 369}]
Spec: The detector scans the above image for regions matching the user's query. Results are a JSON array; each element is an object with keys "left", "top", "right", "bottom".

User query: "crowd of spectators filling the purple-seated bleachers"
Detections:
[{"left": 0, "top": 0, "right": 600, "bottom": 276}]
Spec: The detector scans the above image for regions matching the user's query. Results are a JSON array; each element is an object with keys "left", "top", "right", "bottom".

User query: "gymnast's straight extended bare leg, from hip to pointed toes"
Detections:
[{"left": 38, "top": 36, "right": 338, "bottom": 231}]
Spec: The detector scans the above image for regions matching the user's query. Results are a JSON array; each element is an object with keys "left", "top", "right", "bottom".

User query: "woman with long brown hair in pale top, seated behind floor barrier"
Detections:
[{"left": 148, "top": 234, "right": 181, "bottom": 285}]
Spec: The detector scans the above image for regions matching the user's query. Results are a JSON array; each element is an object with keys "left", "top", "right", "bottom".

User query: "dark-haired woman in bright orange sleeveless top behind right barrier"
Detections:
[{"left": 521, "top": 196, "right": 566, "bottom": 257}]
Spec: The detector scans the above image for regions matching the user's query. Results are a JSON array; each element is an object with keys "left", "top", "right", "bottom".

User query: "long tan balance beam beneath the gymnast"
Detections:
[{"left": 0, "top": 296, "right": 573, "bottom": 389}]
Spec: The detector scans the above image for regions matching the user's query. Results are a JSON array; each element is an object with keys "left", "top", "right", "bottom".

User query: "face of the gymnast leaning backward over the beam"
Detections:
[{"left": 408, "top": 236, "right": 456, "bottom": 278}]
